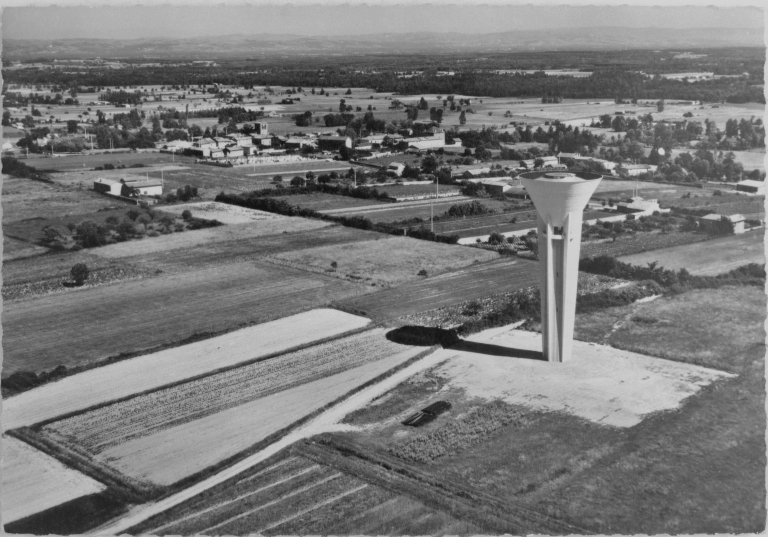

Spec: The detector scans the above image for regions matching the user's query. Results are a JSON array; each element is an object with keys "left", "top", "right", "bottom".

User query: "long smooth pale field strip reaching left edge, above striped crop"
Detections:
[{"left": 3, "top": 309, "right": 369, "bottom": 430}]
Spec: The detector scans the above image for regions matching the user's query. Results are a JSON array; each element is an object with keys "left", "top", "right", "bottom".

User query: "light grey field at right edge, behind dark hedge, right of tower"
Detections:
[{"left": 618, "top": 229, "right": 765, "bottom": 276}]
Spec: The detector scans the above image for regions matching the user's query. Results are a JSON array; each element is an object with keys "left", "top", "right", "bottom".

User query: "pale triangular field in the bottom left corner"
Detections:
[{"left": 2, "top": 436, "right": 106, "bottom": 524}]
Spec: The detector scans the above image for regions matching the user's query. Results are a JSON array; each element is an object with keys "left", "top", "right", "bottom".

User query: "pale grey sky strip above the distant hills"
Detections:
[{"left": 2, "top": 4, "right": 764, "bottom": 39}]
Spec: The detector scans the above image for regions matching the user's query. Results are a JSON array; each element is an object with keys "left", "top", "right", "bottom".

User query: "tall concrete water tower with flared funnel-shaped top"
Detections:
[{"left": 519, "top": 171, "right": 602, "bottom": 362}]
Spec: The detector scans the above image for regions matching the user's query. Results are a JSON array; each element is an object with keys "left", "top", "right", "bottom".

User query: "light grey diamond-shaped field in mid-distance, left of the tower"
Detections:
[{"left": 272, "top": 235, "right": 497, "bottom": 286}]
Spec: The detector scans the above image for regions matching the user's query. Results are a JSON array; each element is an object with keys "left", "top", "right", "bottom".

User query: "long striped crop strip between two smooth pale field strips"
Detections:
[{"left": 45, "top": 330, "right": 403, "bottom": 454}]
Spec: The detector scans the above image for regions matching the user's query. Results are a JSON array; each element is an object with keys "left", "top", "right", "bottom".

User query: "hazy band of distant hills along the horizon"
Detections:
[{"left": 2, "top": 27, "right": 763, "bottom": 61}]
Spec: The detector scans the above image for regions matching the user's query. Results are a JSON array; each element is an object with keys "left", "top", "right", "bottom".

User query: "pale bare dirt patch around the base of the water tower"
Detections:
[{"left": 428, "top": 327, "right": 733, "bottom": 427}]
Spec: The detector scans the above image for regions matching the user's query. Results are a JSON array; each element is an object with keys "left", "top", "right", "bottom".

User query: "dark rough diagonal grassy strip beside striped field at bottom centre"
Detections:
[{"left": 293, "top": 434, "right": 589, "bottom": 535}]
